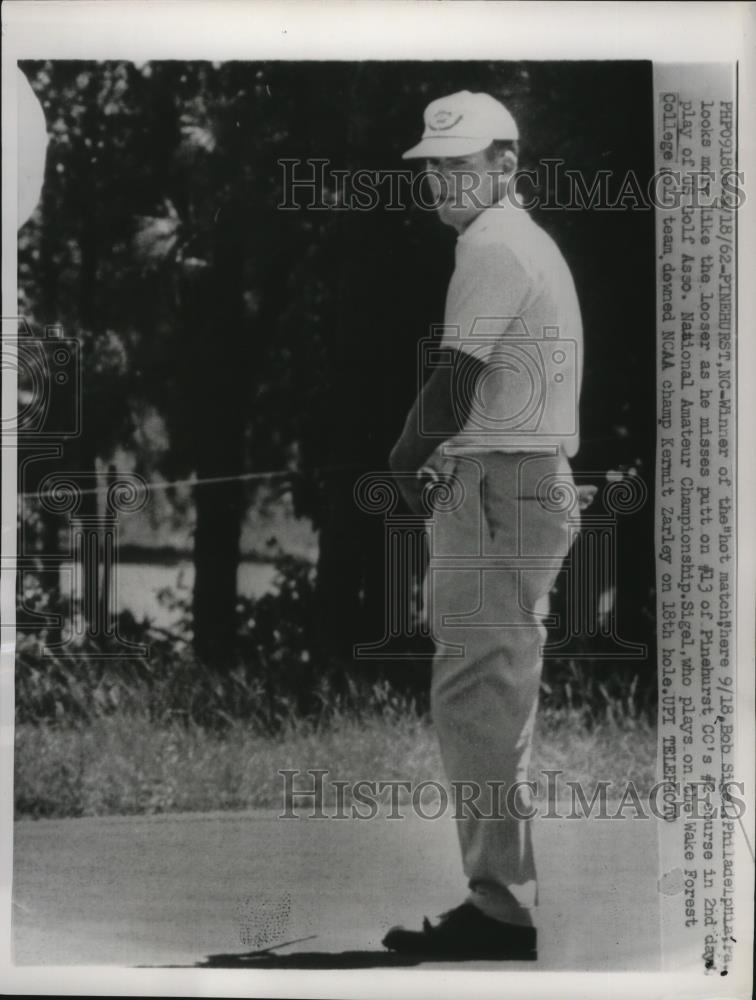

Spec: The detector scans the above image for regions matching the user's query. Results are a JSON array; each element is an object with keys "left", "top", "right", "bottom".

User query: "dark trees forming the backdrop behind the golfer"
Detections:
[{"left": 19, "top": 62, "right": 655, "bottom": 712}]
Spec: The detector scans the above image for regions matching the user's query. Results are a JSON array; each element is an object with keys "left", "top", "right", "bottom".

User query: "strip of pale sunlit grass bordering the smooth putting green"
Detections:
[{"left": 15, "top": 710, "right": 656, "bottom": 818}]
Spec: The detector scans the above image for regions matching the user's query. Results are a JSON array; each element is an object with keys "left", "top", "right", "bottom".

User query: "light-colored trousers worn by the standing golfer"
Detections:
[{"left": 425, "top": 449, "right": 577, "bottom": 920}]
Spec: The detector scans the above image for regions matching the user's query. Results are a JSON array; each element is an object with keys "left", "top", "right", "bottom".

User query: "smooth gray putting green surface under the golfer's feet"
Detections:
[{"left": 13, "top": 810, "right": 659, "bottom": 971}]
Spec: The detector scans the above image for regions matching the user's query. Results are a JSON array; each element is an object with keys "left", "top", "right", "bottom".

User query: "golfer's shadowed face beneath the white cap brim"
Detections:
[{"left": 425, "top": 149, "right": 504, "bottom": 233}]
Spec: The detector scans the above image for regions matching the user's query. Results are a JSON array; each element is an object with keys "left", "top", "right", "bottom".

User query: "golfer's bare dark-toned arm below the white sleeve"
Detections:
[{"left": 389, "top": 351, "right": 485, "bottom": 514}]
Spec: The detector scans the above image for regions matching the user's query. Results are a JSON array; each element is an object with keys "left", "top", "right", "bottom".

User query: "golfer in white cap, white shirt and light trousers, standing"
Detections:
[{"left": 383, "top": 91, "right": 582, "bottom": 960}]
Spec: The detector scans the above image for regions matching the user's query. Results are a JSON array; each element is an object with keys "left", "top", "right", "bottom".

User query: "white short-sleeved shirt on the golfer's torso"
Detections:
[{"left": 441, "top": 199, "right": 583, "bottom": 457}]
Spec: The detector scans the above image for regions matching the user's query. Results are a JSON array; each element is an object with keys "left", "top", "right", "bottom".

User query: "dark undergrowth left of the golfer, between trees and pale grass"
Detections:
[{"left": 16, "top": 556, "right": 400, "bottom": 733}]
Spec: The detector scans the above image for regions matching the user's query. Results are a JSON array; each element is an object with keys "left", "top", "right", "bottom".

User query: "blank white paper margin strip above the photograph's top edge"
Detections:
[{"left": 3, "top": 0, "right": 747, "bottom": 62}]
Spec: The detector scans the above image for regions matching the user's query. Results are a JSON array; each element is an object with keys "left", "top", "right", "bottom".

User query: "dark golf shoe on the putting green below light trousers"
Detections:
[{"left": 383, "top": 903, "right": 538, "bottom": 962}]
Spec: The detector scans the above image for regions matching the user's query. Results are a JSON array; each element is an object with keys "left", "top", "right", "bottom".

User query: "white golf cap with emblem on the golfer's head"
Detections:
[{"left": 402, "top": 90, "right": 519, "bottom": 160}]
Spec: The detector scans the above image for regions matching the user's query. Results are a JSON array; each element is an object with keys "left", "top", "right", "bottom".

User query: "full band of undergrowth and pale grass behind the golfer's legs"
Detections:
[{"left": 15, "top": 554, "right": 656, "bottom": 817}]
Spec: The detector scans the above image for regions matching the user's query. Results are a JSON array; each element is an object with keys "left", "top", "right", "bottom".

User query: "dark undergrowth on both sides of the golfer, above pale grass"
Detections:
[{"left": 16, "top": 555, "right": 654, "bottom": 734}]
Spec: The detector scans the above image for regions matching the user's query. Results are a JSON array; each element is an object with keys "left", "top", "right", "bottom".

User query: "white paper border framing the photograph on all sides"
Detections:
[{"left": 0, "top": 0, "right": 756, "bottom": 1000}]
